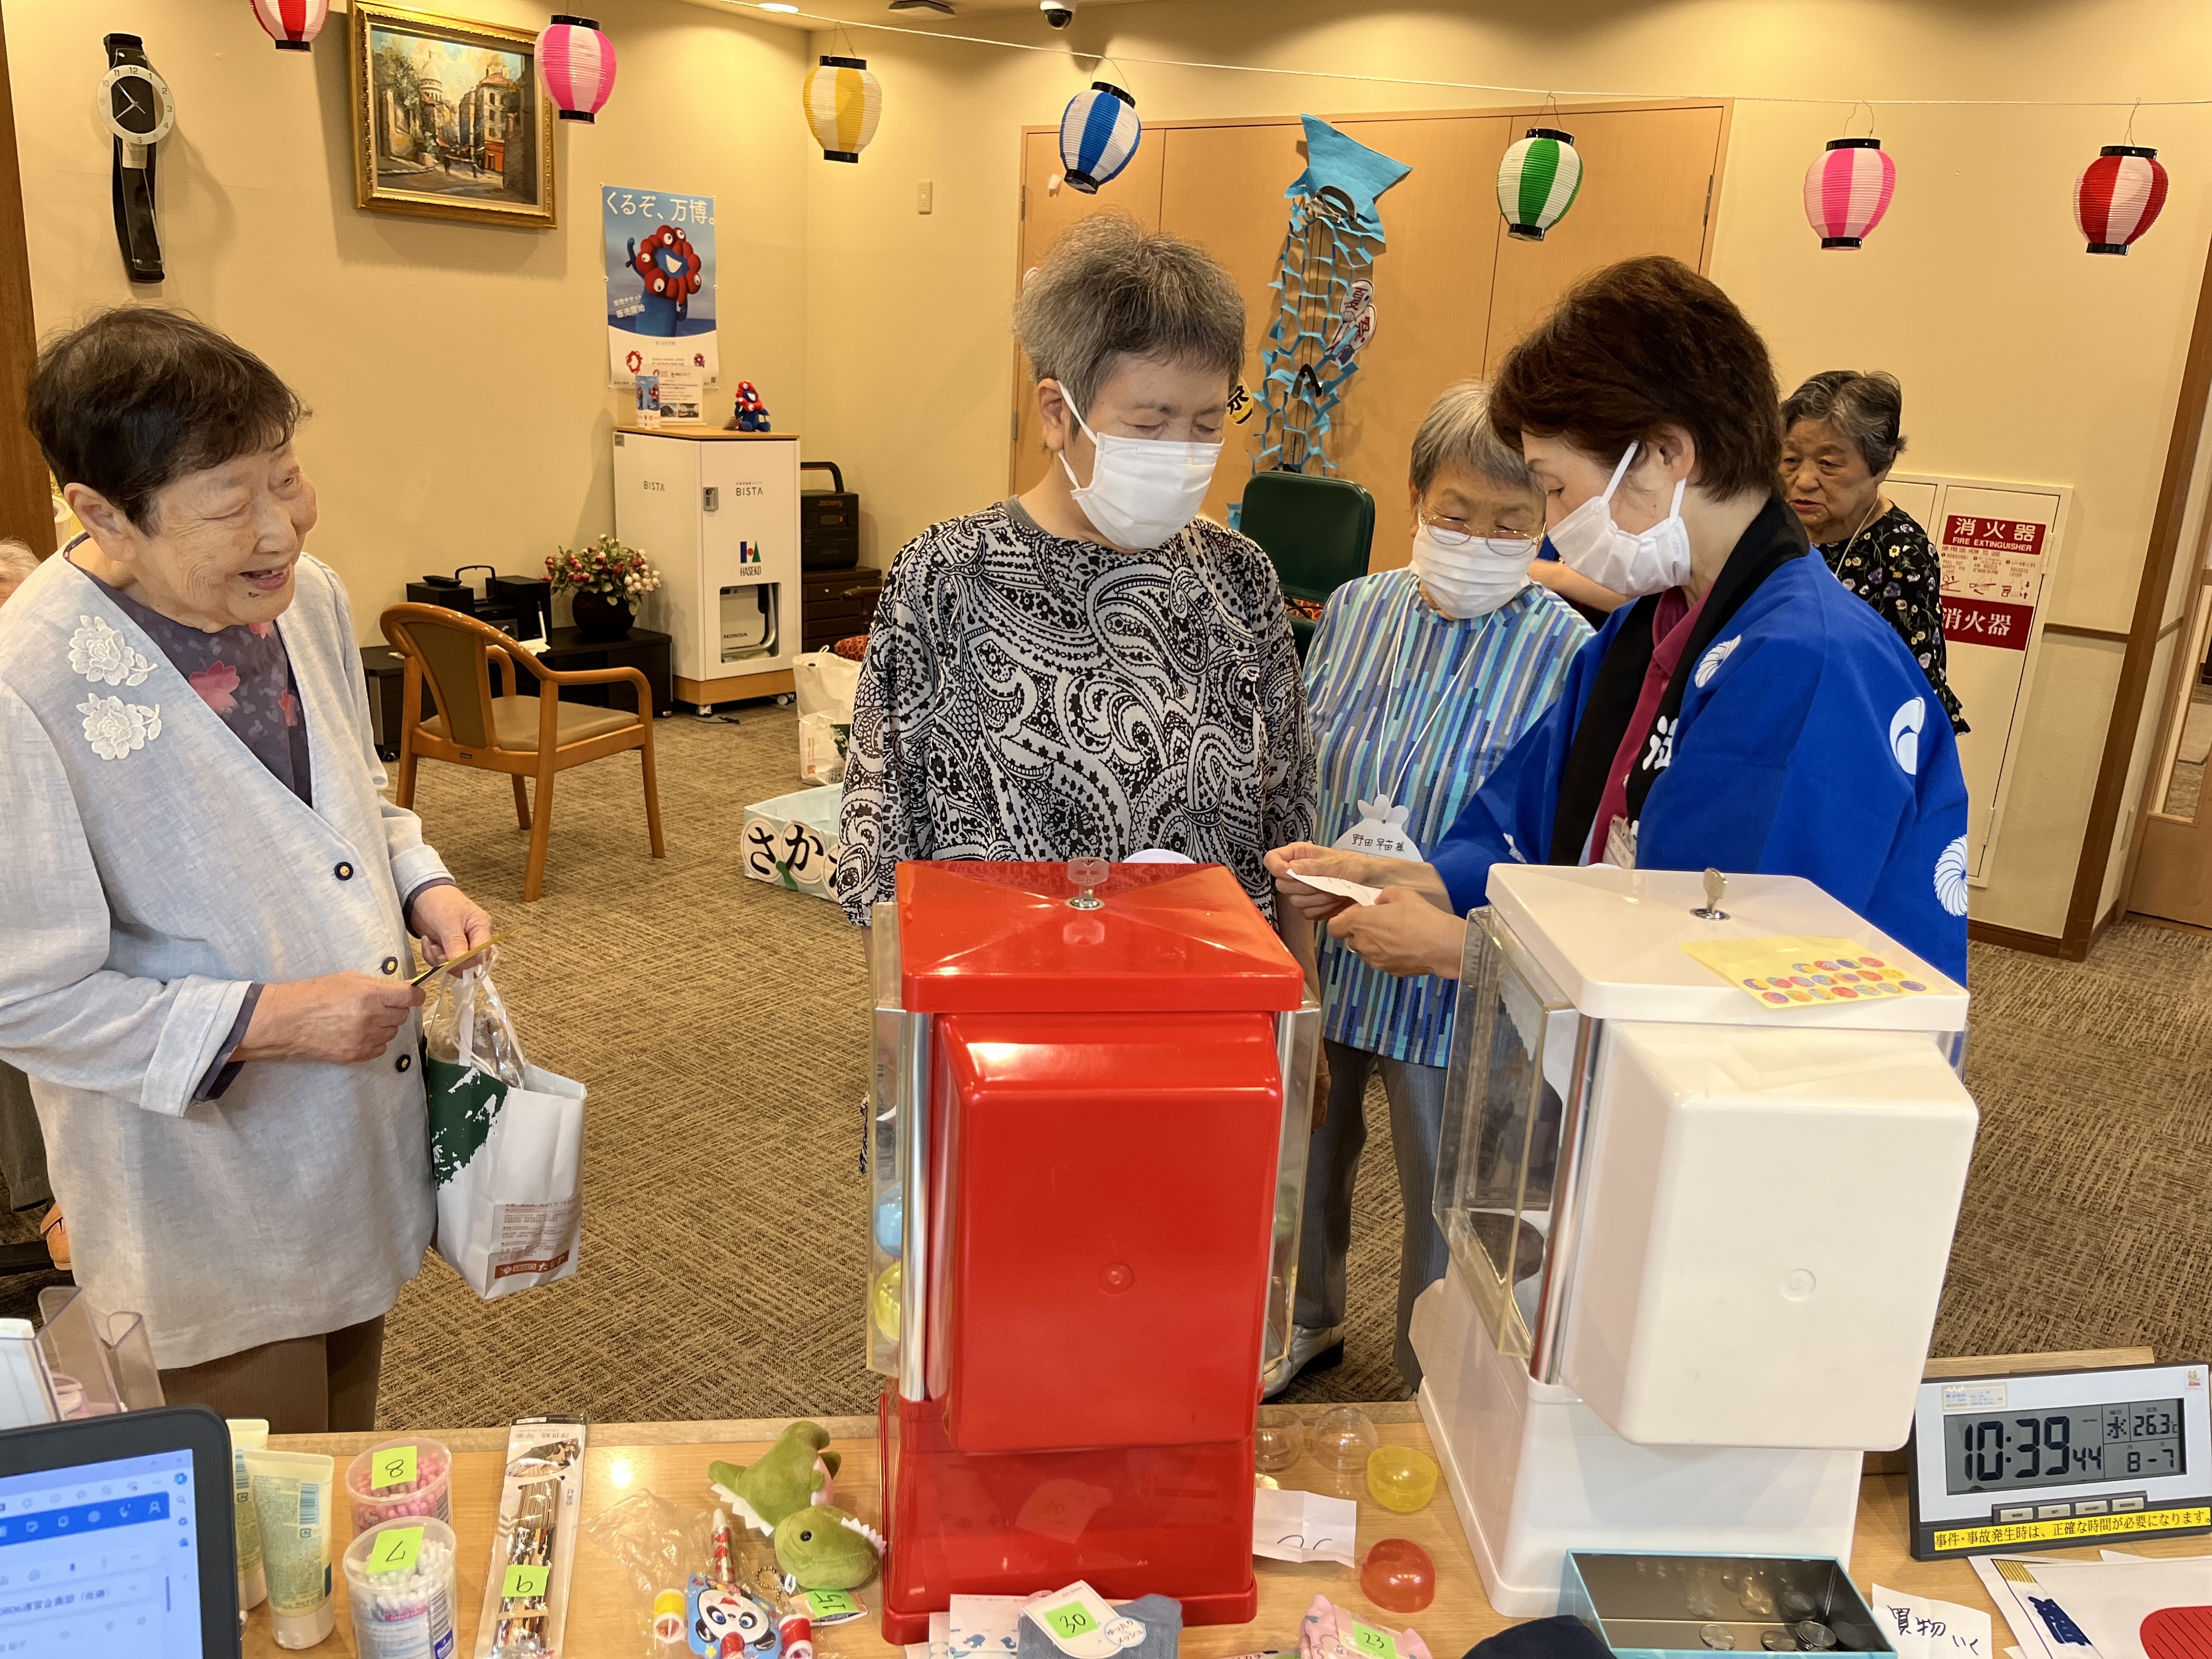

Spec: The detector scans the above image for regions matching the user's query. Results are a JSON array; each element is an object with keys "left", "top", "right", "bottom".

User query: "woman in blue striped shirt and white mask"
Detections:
[{"left": 1267, "top": 381, "right": 1590, "bottom": 1389}]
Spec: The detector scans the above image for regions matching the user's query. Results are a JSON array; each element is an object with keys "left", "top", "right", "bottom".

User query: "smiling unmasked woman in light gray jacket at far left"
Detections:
[{"left": 0, "top": 309, "right": 491, "bottom": 1434}]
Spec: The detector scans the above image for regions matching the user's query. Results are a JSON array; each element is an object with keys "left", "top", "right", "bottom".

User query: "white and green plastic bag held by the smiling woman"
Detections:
[{"left": 422, "top": 969, "right": 584, "bottom": 1301}]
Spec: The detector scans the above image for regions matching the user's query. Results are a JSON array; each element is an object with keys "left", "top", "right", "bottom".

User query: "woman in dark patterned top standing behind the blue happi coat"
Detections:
[{"left": 1783, "top": 369, "right": 1966, "bottom": 732}]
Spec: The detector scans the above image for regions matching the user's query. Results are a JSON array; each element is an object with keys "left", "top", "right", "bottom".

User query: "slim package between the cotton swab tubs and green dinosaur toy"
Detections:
[{"left": 476, "top": 1418, "right": 586, "bottom": 1659}]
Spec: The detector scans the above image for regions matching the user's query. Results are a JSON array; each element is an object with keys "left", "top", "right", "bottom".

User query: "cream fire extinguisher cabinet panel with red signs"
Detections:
[{"left": 1884, "top": 473, "right": 2073, "bottom": 887}]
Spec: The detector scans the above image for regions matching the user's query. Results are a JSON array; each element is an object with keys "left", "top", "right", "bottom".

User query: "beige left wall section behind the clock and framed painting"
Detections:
[{"left": 7, "top": 0, "right": 805, "bottom": 639}]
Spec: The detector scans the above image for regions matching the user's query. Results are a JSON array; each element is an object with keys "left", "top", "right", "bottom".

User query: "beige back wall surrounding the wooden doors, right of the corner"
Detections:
[{"left": 808, "top": 0, "right": 2212, "bottom": 936}]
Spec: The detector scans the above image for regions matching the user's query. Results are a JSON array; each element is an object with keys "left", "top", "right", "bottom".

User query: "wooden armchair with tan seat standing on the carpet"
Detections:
[{"left": 383, "top": 604, "right": 668, "bottom": 900}]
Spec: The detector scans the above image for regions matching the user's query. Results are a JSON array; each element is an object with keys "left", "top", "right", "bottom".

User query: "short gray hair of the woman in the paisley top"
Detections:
[{"left": 1013, "top": 212, "right": 1243, "bottom": 414}]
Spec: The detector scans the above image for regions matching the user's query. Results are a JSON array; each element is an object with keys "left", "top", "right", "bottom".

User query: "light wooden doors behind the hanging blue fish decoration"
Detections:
[{"left": 1013, "top": 104, "right": 1728, "bottom": 568}]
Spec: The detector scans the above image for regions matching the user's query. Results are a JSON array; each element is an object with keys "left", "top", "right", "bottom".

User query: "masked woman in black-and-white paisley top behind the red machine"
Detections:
[{"left": 836, "top": 217, "right": 1314, "bottom": 960}]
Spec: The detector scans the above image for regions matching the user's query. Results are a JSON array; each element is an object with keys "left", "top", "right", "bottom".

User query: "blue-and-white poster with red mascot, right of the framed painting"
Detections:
[{"left": 600, "top": 184, "right": 721, "bottom": 387}]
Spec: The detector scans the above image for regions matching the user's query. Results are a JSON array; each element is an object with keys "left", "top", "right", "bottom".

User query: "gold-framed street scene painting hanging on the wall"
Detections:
[{"left": 352, "top": 0, "right": 557, "bottom": 228}]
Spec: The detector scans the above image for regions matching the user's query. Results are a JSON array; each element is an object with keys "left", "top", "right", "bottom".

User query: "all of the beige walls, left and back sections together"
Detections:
[{"left": 7, "top": 0, "right": 2212, "bottom": 934}]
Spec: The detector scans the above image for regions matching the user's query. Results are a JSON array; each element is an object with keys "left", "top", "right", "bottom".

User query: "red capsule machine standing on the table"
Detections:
[{"left": 870, "top": 858, "right": 1321, "bottom": 1644}]
